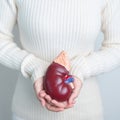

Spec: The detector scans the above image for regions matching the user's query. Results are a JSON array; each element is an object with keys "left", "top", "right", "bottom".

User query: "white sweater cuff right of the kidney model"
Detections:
[{"left": 70, "top": 56, "right": 89, "bottom": 82}]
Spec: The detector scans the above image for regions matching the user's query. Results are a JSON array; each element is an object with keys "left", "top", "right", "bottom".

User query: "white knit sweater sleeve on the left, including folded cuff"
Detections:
[{"left": 0, "top": 0, "right": 49, "bottom": 83}]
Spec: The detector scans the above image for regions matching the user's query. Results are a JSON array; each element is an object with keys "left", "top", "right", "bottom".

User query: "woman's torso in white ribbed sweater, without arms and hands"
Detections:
[{"left": 12, "top": 0, "right": 104, "bottom": 120}]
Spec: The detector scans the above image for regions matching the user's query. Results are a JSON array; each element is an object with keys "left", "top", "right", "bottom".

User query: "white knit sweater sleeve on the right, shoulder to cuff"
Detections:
[{"left": 71, "top": 0, "right": 120, "bottom": 80}]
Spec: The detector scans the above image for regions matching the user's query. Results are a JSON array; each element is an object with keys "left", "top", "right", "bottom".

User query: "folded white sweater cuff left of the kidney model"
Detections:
[{"left": 21, "top": 54, "right": 49, "bottom": 83}]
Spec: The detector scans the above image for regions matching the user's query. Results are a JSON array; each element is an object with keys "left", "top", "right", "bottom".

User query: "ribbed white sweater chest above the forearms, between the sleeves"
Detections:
[{"left": 16, "top": 0, "right": 104, "bottom": 61}]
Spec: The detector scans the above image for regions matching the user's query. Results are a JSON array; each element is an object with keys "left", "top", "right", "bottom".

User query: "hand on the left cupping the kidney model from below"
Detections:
[{"left": 34, "top": 78, "right": 66, "bottom": 112}]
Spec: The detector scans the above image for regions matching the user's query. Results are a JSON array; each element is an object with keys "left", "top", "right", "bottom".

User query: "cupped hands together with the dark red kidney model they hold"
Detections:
[{"left": 34, "top": 51, "right": 82, "bottom": 112}]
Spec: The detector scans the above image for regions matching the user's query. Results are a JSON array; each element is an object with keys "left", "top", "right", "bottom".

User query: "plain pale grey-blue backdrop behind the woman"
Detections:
[{"left": 0, "top": 26, "right": 120, "bottom": 120}]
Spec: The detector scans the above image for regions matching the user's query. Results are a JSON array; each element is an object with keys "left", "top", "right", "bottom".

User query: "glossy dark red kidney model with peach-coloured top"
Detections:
[{"left": 43, "top": 51, "right": 74, "bottom": 102}]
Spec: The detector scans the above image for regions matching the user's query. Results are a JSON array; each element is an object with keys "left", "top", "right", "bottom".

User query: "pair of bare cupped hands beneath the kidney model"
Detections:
[{"left": 34, "top": 77, "right": 82, "bottom": 112}]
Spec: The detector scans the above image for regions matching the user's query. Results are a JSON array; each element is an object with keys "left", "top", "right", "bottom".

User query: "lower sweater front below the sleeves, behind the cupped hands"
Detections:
[{"left": 12, "top": 74, "right": 103, "bottom": 120}]
